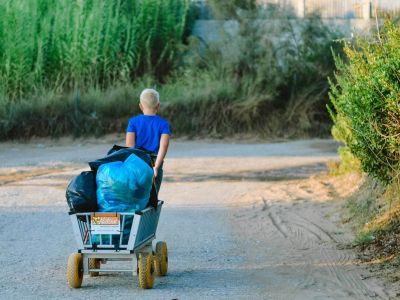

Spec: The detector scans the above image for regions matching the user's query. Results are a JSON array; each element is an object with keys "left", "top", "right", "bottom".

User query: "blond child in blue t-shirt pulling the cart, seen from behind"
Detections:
[{"left": 126, "top": 89, "right": 171, "bottom": 192}]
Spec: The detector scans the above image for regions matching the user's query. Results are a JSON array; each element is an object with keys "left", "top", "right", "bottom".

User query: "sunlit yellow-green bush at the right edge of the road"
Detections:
[{"left": 330, "top": 22, "right": 400, "bottom": 184}]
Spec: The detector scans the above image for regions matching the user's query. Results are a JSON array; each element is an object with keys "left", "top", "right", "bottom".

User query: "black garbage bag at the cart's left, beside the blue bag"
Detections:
[{"left": 65, "top": 171, "right": 97, "bottom": 213}]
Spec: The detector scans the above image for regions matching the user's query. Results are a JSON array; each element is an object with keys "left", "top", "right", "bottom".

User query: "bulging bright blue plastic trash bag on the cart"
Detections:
[{"left": 96, "top": 154, "right": 153, "bottom": 212}]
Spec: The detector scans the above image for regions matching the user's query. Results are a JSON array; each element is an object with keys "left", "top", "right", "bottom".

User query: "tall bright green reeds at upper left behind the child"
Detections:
[{"left": 0, "top": 0, "right": 190, "bottom": 100}]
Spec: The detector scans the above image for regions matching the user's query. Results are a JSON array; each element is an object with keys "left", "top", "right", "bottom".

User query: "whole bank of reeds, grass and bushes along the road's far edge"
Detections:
[{"left": 0, "top": 0, "right": 340, "bottom": 139}]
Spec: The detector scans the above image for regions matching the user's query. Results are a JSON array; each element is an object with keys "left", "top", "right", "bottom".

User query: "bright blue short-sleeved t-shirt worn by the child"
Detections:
[{"left": 126, "top": 115, "right": 171, "bottom": 154}]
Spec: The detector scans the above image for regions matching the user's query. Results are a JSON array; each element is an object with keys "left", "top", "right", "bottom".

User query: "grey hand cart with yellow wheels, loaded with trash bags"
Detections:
[{"left": 67, "top": 201, "right": 168, "bottom": 289}]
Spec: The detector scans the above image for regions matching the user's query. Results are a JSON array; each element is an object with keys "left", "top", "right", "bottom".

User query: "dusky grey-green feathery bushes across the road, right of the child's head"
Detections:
[{"left": 170, "top": 7, "right": 340, "bottom": 136}]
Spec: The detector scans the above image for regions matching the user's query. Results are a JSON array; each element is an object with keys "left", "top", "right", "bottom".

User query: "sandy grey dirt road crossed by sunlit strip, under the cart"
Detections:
[{"left": 0, "top": 139, "right": 389, "bottom": 299}]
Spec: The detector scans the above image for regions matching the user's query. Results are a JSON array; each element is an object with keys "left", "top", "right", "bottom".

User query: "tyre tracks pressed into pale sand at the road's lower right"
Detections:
[{"left": 264, "top": 203, "right": 383, "bottom": 299}]
